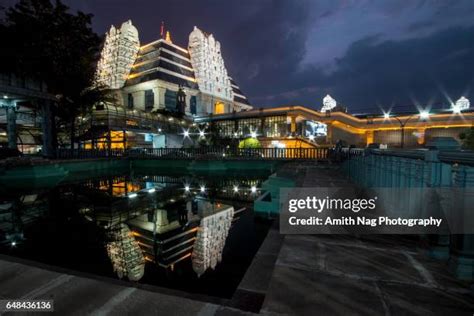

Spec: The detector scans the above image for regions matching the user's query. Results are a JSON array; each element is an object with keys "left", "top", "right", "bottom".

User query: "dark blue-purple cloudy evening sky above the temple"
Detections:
[{"left": 2, "top": 0, "right": 474, "bottom": 112}]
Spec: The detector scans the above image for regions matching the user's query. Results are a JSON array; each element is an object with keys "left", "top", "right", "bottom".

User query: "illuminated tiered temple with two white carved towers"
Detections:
[{"left": 96, "top": 21, "right": 252, "bottom": 116}]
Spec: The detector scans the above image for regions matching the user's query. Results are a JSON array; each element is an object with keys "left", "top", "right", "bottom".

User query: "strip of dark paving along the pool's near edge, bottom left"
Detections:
[{"left": 0, "top": 260, "right": 252, "bottom": 315}]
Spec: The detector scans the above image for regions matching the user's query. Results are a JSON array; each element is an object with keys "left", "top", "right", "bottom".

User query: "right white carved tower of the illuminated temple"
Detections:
[{"left": 188, "top": 27, "right": 233, "bottom": 100}]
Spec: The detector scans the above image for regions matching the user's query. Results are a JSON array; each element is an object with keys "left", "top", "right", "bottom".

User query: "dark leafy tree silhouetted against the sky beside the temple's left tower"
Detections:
[{"left": 0, "top": 0, "right": 107, "bottom": 147}]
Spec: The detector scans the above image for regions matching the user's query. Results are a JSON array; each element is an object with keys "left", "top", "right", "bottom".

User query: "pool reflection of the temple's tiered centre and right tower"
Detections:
[{"left": 128, "top": 199, "right": 234, "bottom": 275}]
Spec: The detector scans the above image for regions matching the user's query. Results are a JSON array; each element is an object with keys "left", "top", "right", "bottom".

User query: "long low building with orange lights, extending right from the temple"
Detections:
[{"left": 195, "top": 96, "right": 474, "bottom": 148}]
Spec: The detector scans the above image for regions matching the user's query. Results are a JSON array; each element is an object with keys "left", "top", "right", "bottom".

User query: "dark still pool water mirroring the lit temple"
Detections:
[{"left": 0, "top": 172, "right": 270, "bottom": 298}]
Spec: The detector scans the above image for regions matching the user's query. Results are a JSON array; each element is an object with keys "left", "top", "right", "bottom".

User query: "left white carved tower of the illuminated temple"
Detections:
[{"left": 96, "top": 20, "right": 140, "bottom": 89}]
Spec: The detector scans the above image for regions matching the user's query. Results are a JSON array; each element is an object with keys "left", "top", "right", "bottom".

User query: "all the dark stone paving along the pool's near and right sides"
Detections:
[{"left": 0, "top": 164, "right": 474, "bottom": 315}]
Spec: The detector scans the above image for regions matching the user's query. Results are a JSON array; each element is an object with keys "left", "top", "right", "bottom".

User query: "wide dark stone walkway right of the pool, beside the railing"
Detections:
[{"left": 260, "top": 164, "right": 474, "bottom": 315}]
